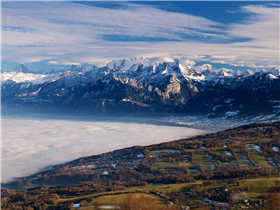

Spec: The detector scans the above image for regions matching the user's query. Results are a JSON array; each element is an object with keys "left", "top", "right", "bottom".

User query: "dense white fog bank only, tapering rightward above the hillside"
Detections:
[{"left": 2, "top": 116, "right": 210, "bottom": 182}]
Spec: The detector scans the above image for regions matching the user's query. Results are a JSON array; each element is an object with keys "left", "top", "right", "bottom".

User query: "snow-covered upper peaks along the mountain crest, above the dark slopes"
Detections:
[{"left": 1, "top": 56, "right": 280, "bottom": 89}]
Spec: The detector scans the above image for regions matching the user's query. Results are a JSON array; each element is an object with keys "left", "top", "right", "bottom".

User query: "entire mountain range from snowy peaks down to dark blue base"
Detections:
[{"left": 1, "top": 57, "right": 280, "bottom": 117}]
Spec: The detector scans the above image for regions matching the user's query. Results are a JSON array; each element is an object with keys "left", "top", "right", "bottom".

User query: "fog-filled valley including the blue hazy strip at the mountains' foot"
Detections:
[{"left": 1, "top": 106, "right": 274, "bottom": 182}]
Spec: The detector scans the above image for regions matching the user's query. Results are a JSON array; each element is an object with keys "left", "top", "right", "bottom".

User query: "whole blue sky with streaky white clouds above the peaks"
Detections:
[{"left": 2, "top": 1, "right": 279, "bottom": 70}]
